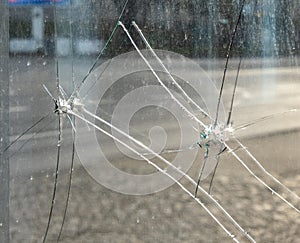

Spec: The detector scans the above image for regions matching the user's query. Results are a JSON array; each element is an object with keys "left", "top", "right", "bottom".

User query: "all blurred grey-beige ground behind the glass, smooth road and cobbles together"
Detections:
[{"left": 6, "top": 56, "right": 300, "bottom": 242}]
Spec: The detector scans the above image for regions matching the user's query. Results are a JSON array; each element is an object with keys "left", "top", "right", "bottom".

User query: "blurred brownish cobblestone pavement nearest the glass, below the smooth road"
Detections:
[{"left": 11, "top": 132, "right": 300, "bottom": 242}]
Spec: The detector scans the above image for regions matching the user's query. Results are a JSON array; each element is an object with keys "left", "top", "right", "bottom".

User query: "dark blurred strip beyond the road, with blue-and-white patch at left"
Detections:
[{"left": 8, "top": 0, "right": 300, "bottom": 58}]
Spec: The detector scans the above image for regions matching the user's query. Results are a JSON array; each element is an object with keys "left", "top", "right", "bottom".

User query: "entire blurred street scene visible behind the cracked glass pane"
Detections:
[{"left": 0, "top": 0, "right": 300, "bottom": 242}]
